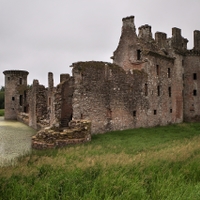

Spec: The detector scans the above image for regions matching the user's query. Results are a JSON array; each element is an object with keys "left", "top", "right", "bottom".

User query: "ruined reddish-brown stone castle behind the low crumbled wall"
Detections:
[{"left": 3, "top": 16, "right": 200, "bottom": 147}]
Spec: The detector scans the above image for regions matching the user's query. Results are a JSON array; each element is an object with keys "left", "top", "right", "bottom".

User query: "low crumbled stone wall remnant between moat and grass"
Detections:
[{"left": 32, "top": 120, "right": 91, "bottom": 149}]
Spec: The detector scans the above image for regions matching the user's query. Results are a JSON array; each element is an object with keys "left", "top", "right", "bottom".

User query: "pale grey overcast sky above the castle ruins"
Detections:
[{"left": 0, "top": 0, "right": 200, "bottom": 86}]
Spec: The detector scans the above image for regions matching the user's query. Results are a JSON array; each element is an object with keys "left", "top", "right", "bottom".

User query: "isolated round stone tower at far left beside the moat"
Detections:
[{"left": 3, "top": 70, "right": 29, "bottom": 120}]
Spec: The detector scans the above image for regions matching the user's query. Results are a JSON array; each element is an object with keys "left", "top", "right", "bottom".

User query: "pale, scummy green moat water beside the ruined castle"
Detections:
[{"left": 0, "top": 117, "right": 36, "bottom": 166}]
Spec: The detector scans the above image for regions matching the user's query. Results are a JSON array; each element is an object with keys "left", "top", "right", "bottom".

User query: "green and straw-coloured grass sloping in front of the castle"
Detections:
[{"left": 0, "top": 123, "right": 200, "bottom": 200}]
